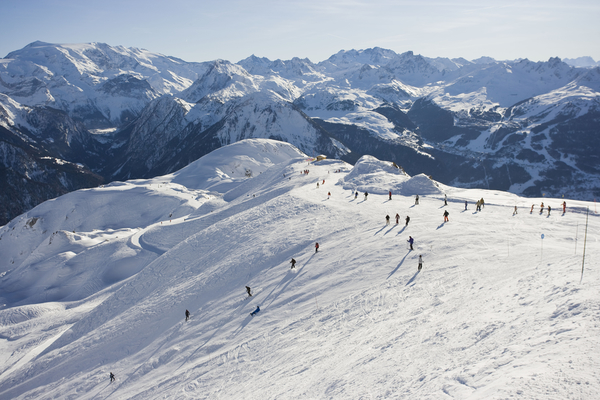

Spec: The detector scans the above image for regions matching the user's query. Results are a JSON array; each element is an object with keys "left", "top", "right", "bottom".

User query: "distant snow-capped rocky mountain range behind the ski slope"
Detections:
[{"left": 0, "top": 42, "right": 600, "bottom": 228}]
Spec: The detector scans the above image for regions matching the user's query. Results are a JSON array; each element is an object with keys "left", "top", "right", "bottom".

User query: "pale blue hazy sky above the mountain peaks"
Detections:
[{"left": 0, "top": 0, "right": 600, "bottom": 62}]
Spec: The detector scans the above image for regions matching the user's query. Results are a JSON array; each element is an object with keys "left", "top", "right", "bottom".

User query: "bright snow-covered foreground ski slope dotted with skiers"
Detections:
[{"left": 0, "top": 139, "right": 600, "bottom": 399}]
